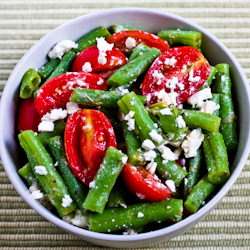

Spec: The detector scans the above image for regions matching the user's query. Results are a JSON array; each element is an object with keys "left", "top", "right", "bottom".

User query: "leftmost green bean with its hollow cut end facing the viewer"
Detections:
[{"left": 19, "top": 69, "right": 41, "bottom": 99}]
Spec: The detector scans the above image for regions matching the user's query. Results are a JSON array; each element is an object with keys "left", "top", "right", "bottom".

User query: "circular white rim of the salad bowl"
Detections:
[{"left": 0, "top": 7, "right": 250, "bottom": 242}]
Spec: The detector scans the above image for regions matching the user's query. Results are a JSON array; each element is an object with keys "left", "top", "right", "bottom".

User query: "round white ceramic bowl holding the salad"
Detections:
[{"left": 0, "top": 8, "right": 250, "bottom": 247}]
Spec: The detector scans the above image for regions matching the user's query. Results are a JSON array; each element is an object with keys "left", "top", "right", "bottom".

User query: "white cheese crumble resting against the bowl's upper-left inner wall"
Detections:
[{"left": 48, "top": 40, "right": 78, "bottom": 59}]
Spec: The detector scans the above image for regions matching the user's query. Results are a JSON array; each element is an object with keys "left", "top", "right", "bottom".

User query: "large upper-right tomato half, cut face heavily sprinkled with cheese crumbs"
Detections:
[{"left": 142, "top": 46, "right": 210, "bottom": 104}]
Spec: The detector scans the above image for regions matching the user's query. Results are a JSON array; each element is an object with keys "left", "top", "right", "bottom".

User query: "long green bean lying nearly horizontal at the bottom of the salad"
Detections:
[{"left": 89, "top": 199, "right": 183, "bottom": 233}]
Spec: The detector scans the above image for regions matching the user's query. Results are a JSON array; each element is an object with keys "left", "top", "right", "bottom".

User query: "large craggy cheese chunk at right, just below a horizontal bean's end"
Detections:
[{"left": 181, "top": 129, "right": 204, "bottom": 158}]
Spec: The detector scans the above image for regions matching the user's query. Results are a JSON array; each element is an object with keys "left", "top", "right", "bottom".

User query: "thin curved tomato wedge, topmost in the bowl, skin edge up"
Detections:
[{"left": 107, "top": 30, "right": 169, "bottom": 52}]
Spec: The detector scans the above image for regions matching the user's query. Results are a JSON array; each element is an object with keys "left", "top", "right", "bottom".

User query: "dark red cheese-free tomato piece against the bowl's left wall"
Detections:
[{"left": 18, "top": 97, "right": 41, "bottom": 132}]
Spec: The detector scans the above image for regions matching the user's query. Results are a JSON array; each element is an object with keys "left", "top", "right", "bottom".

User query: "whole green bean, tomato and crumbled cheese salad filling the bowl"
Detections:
[{"left": 18, "top": 25, "right": 237, "bottom": 235}]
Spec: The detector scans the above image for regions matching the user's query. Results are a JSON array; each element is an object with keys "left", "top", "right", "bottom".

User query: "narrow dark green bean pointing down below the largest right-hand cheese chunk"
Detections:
[{"left": 184, "top": 149, "right": 202, "bottom": 197}]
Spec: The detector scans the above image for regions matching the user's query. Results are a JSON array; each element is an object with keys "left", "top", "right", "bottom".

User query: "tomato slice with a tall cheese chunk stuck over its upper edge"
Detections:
[{"left": 72, "top": 46, "right": 127, "bottom": 72}]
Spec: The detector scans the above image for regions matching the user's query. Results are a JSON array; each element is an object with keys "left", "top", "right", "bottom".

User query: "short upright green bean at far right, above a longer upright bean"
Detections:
[{"left": 212, "top": 63, "right": 232, "bottom": 96}]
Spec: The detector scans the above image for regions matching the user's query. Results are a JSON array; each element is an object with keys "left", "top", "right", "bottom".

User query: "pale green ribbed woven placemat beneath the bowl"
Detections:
[{"left": 0, "top": 0, "right": 250, "bottom": 249}]
